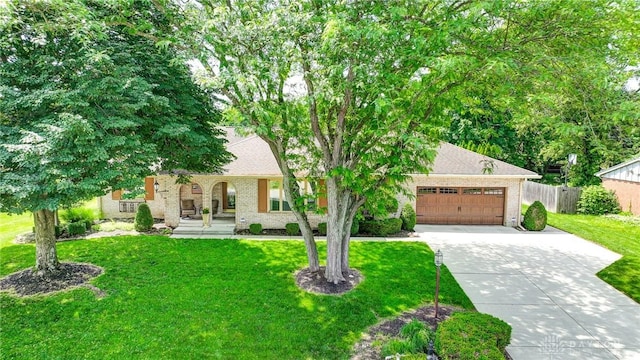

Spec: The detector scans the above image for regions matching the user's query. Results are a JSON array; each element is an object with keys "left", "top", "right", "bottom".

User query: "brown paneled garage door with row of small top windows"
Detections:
[{"left": 416, "top": 186, "right": 505, "bottom": 225}]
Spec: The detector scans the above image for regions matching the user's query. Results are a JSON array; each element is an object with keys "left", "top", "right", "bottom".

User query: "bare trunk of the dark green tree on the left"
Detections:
[{"left": 33, "top": 210, "right": 60, "bottom": 275}]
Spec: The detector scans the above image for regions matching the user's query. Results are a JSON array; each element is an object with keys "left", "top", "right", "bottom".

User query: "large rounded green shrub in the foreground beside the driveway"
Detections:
[{"left": 435, "top": 312, "right": 511, "bottom": 360}]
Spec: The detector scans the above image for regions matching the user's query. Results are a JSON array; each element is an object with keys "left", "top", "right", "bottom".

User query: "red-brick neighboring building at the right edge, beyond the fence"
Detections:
[{"left": 595, "top": 157, "right": 640, "bottom": 215}]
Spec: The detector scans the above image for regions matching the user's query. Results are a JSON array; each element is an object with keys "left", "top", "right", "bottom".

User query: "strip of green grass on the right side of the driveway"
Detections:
[{"left": 547, "top": 212, "right": 640, "bottom": 303}]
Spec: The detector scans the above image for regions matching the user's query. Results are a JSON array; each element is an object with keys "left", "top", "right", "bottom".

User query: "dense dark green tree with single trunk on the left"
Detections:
[{"left": 0, "top": 0, "right": 228, "bottom": 274}]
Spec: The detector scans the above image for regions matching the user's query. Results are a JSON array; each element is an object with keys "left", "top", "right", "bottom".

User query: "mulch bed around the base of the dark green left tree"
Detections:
[{"left": 0, "top": 263, "right": 104, "bottom": 297}]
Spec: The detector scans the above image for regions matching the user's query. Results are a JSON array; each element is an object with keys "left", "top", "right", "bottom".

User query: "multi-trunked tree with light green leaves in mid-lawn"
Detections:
[{"left": 182, "top": 0, "right": 634, "bottom": 282}]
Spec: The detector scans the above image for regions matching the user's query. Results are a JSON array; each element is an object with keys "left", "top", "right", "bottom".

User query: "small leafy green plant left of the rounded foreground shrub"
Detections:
[{"left": 382, "top": 320, "right": 435, "bottom": 359}]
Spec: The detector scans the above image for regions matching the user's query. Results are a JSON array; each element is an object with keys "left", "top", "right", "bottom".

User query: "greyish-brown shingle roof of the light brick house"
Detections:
[{"left": 224, "top": 128, "right": 539, "bottom": 178}]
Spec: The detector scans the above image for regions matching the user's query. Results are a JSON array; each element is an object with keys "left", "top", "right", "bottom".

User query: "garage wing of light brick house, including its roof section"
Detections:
[{"left": 399, "top": 142, "right": 540, "bottom": 226}]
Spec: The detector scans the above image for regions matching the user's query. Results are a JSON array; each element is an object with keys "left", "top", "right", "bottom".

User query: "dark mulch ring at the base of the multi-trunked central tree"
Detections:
[{"left": 295, "top": 266, "right": 364, "bottom": 295}]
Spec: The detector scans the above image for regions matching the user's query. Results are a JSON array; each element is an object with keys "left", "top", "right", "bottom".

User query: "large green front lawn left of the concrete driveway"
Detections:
[{"left": 0, "top": 236, "right": 472, "bottom": 359}]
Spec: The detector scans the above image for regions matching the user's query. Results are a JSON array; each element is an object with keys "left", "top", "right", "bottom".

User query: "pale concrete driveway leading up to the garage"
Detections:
[{"left": 416, "top": 225, "right": 640, "bottom": 360}]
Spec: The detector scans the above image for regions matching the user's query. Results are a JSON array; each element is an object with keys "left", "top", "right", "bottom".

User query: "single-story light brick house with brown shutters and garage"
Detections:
[{"left": 101, "top": 128, "right": 540, "bottom": 229}]
